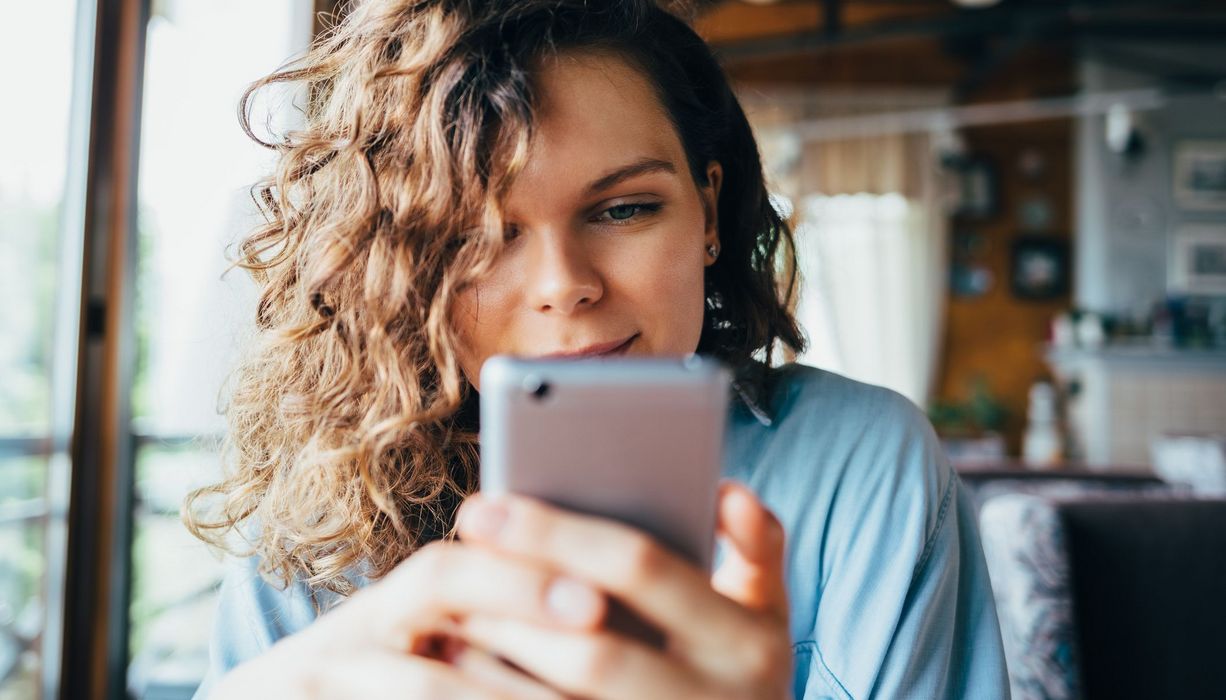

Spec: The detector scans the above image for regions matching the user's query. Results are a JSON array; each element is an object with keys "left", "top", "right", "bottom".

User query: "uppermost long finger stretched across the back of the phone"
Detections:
[{"left": 459, "top": 495, "right": 754, "bottom": 650}]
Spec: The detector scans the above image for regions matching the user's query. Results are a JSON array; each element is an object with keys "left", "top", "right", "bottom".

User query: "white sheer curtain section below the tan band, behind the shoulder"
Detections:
[{"left": 796, "top": 192, "right": 945, "bottom": 406}]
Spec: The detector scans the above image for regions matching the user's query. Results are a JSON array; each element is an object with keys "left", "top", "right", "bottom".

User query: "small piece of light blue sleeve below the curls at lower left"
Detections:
[{"left": 192, "top": 557, "right": 316, "bottom": 700}]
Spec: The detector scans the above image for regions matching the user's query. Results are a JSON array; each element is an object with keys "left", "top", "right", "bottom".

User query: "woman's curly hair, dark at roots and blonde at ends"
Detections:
[{"left": 184, "top": 0, "right": 803, "bottom": 595}]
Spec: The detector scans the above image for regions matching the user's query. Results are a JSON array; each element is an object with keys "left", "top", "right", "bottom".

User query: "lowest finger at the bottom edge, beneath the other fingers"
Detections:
[{"left": 461, "top": 615, "right": 702, "bottom": 700}]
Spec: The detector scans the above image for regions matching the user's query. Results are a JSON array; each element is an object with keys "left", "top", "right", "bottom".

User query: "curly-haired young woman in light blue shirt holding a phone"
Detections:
[{"left": 185, "top": 0, "right": 1008, "bottom": 700}]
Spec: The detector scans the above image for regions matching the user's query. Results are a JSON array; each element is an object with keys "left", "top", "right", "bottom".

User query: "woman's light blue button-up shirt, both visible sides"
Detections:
[{"left": 196, "top": 365, "right": 1009, "bottom": 700}]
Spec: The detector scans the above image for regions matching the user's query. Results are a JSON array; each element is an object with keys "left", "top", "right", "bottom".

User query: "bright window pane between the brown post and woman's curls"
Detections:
[{"left": 128, "top": 0, "right": 313, "bottom": 698}]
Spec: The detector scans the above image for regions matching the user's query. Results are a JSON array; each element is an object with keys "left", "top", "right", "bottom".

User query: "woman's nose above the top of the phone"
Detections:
[{"left": 527, "top": 232, "right": 604, "bottom": 314}]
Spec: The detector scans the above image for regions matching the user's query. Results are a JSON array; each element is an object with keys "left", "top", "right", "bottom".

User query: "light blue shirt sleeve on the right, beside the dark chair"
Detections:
[{"left": 794, "top": 397, "right": 1009, "bottom": 700}]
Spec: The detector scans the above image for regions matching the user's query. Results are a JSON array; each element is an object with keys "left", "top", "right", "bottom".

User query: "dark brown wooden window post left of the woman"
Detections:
[{"left": 52, "top": 0, "right": 345, "bottom": 700}]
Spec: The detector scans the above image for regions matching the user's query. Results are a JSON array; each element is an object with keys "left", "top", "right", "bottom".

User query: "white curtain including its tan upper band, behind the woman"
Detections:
[{"left": 747, "top": 93, "right": 951, "bottom": 406}]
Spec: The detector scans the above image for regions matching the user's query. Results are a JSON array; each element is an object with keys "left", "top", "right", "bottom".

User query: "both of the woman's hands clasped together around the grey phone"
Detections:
[{"left": 212, "top": 484, "right": 791, "bottom": 700}]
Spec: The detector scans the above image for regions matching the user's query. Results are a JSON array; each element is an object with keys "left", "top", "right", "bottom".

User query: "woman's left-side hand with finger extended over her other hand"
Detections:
[{"left": 211, "top": 543, "right": 606, "bottom": 700}]
